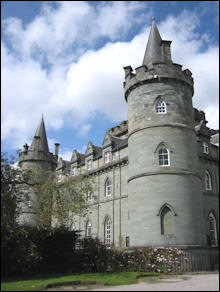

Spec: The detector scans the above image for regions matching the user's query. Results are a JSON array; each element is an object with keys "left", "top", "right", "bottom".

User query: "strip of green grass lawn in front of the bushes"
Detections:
[{"left": 1, "top": 272, "right": 160, "bottom": 291}]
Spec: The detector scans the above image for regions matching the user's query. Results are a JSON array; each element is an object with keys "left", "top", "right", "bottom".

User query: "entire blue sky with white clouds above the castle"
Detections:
[{"left": 1, "top": 1, "right": 219, "bottom": 160}]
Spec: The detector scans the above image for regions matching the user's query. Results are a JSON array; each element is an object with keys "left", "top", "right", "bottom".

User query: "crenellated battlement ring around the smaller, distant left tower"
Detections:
[{"left": 19, "top": 150, "right": 57, "bottom": 165}]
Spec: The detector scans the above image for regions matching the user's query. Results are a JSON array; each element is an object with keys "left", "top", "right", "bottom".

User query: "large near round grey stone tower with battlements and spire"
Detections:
[{"left": 124, "top": 21, "right": 206, "bottom": 247}]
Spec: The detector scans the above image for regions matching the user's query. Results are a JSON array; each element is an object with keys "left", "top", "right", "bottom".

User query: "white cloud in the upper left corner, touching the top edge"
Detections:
[{"left": 3, "top": 1, "right": 146, "bottom": 65}]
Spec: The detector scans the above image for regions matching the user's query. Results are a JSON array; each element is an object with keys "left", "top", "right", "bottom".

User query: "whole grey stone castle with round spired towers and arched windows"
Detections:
[{"left": 19, "top": 20, "right": 219, "bottom": 256}]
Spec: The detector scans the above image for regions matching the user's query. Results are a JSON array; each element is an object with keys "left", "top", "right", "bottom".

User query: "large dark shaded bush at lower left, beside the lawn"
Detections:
[{"left": 1, "top": 226, "right": 78, "bottom": 278}]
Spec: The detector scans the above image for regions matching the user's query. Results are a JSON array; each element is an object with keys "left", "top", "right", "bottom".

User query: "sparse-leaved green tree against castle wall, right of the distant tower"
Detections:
[{"left": 33, "top": 173, "right": 96, "bottom": 228}]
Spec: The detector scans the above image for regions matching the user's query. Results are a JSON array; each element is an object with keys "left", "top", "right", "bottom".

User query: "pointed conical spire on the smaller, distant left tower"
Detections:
[{"left": 30, "top": 115, "right": 49, "bottom": 152}]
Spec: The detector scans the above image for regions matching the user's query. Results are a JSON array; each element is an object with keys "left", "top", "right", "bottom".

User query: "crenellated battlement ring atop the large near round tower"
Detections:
[{"left": 124, "top": 63, "right": 193, "bottom": 101}]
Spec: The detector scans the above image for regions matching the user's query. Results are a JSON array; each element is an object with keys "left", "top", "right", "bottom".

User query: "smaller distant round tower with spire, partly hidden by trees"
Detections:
[{"left": 18, "top": 117, "right": 59, "bottom": 224}]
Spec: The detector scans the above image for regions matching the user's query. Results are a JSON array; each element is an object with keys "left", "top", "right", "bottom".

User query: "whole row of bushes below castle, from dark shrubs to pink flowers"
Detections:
[{"left": 1, "top": 226, "right": 187, "bottom": 278}]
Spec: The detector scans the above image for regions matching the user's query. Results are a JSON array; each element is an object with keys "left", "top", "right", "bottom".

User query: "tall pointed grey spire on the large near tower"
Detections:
[{"left": 143, "top": 17, "right": 162, "bottom": 67}]
